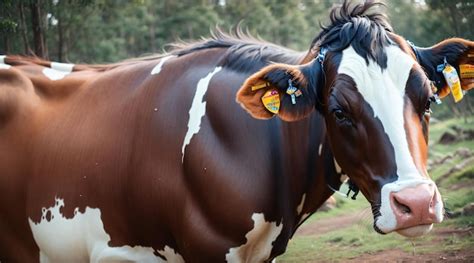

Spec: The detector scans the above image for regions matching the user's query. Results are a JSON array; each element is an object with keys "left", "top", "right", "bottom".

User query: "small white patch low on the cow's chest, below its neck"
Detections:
[{"left": 225, "top": 213, "right": 283, "bottom": 263}]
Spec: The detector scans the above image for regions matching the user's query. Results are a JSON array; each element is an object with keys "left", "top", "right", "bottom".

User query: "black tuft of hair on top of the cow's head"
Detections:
[{"left": 311, "top": 0, "right": 394, "bottom": 68}]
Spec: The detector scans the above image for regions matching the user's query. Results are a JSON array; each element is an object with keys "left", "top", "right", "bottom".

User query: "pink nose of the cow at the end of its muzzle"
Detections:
[{"left": 390, "top": 183, "right": 439, "bottom": 229}]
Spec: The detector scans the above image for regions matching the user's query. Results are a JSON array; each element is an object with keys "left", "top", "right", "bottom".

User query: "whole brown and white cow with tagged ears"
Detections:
[{"left": 0, "top": 1, "right": 474, "bottom": 262}]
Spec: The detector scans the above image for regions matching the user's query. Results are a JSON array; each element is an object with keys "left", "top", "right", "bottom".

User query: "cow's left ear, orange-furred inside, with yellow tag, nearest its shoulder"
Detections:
[{"left": 236, "top": 61, "right": 321, "bottom": 121}]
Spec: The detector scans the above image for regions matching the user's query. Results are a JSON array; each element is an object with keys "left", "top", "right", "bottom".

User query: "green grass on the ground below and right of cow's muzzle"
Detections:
[{"left": 277, "top": 117, "right": 474, "bottom": 262}]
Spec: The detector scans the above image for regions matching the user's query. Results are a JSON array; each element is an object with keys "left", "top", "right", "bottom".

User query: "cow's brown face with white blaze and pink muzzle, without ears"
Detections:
[{"left": 323, "top": 45, "right": 443, "bottom": 236}]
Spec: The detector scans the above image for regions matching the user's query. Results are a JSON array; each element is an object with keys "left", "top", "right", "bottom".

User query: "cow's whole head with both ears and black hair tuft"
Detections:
[{"left": 237, "top": 1, "right": 474, "bottom": 236}]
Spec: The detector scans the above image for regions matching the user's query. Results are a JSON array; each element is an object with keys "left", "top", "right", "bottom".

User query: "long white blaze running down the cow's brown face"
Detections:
[{"left": 338, "top": 46, "right": 442, "bottom": 235}]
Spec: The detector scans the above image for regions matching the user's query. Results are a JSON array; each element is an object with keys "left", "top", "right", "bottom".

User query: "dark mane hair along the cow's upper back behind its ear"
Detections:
[{"left": 170, "top": 26, "right": 304, "bottom": 72}]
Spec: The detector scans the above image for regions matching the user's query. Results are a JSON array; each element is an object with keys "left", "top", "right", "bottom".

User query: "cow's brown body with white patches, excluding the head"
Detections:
[{"left": 0, "top": 45, "right": 339, "bottom": 262}]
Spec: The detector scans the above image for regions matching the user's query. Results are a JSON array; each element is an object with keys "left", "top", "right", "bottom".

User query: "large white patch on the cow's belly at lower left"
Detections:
[{"left": 28, "top": 198, "right": 184, "bottom": 262}]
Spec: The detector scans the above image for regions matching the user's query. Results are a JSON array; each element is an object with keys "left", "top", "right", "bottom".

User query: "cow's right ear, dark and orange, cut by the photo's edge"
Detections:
[{"left": 414, "top": 38, "right": 474, "bottom": 98}]
